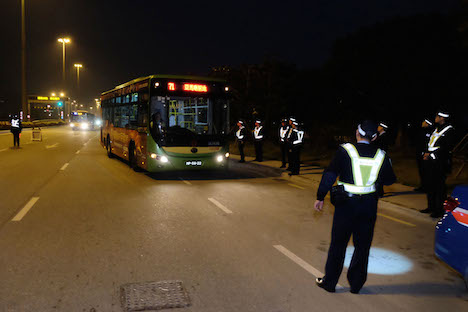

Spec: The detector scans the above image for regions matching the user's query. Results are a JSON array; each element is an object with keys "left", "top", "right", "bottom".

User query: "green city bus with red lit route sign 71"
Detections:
[{"left": 101, "top": 75, "right": 229, "bottom": 172}]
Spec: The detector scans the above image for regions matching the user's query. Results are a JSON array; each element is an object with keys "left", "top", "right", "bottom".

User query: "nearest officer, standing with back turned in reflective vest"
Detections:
[{"left": 314, "top": 121, "right": 396, "bottom": 294}]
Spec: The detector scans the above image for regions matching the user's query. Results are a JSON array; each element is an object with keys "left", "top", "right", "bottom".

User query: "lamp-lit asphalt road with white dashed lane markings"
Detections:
[{"left": 0, "top": 127, "right": 468, "bottom": 312}]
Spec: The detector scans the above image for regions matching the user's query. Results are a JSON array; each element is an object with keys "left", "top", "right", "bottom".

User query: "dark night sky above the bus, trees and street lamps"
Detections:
[{"left": 0, "top": 0, "right": 459, "bottom": 113}]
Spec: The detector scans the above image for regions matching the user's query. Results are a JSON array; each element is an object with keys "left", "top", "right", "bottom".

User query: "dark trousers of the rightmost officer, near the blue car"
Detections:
[{"left": 423, "top": 160, "right": 447, "bottom": 215}]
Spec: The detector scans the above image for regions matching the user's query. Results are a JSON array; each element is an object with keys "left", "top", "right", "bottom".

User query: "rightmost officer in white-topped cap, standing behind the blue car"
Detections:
[{"left": 421, "top": 110, "right": 455, "bottom": 218}]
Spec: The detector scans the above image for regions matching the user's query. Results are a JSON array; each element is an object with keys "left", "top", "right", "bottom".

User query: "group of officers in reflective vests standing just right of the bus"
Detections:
[{"left": 236, "top": 117, "right": 304, "bottom": 175}]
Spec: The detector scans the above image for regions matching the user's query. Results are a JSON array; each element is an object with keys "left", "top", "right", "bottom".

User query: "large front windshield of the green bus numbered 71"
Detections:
[{"left": 150, "top": 96, "right": 227, "bottom": 146}]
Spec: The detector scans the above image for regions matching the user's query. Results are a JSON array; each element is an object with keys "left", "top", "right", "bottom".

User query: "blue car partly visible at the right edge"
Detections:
[{"left": 434, "top": 185, "right": 468, "bottom": 287}]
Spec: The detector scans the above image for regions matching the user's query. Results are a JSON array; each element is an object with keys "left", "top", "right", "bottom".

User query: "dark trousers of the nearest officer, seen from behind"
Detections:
[{"left": 325, "top": 195, "right": 377, "bottom": 291}]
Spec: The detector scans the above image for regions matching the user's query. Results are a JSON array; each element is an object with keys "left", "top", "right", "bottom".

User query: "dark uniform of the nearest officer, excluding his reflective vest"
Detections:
[{"left": 317, "top": 121, "right": 396, "bottom": 293}]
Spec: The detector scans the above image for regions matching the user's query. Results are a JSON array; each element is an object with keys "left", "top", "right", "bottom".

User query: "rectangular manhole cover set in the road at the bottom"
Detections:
[{"left": 120, "top": 281, "right": 190, "bottom": 312}]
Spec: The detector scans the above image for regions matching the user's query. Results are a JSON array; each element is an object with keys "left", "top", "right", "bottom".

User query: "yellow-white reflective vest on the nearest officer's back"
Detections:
[{"left": 338, "top": 143, "right": 385, "bottom": 194}]
